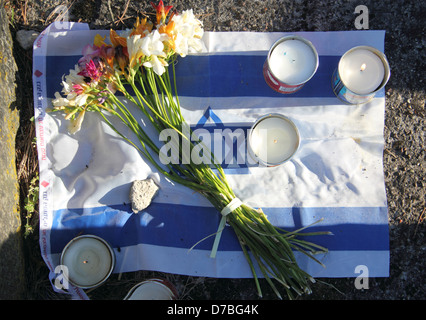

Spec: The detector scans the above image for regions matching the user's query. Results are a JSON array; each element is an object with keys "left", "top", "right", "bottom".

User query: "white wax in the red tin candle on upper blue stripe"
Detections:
[{"left": 269, "top": 40, "right": 317, "bottom": 85}]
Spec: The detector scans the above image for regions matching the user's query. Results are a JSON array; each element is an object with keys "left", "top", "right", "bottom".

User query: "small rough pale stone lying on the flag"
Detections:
[{"left": 130, "top": 179, "right": 160, "bottom": 213}]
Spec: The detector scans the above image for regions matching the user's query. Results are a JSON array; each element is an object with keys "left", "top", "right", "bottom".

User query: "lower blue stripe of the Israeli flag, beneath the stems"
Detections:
[{"left": 51, "top": 203, "right": 389, "bottom": 253}]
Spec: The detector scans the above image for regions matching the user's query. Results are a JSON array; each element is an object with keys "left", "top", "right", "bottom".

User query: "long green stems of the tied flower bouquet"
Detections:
[{"left": 100, "top": 58, "right": 328, "bottom": 298}]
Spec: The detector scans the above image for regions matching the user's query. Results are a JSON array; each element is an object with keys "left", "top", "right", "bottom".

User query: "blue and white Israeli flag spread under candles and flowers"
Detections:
[{"left": 33, "top": 23, "right": 389, "bottom": 296}]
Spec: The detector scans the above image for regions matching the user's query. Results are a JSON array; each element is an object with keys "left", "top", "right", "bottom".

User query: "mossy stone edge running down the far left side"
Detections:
[{"left": 0, "top": 6, "right": 25, "bottom": 299}]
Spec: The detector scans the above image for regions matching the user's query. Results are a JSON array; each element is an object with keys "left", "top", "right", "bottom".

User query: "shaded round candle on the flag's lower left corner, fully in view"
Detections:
[{"left": 62, "top": 237, "right": 113, "bottom": 287}]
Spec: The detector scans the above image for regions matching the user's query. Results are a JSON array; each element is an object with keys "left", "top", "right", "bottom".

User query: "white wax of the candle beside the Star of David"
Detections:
[{"left": 250, "top": 116, "right": 299, "bottom": 165}]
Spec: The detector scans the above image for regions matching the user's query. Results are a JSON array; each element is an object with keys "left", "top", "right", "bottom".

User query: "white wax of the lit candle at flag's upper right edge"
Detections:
[{"left": 339, "top": 49, "right": 385, "bottom": 94}]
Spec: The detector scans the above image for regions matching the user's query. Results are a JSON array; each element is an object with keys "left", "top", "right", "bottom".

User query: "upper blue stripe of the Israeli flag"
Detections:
[{"left": 46, "top": 53, "right": 340, "bottom": 99}]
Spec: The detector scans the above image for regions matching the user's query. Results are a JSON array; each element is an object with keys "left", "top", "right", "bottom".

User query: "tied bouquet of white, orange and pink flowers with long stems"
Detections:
[{"left": 52, "top": 1, "right": 327, "bottom": 298}]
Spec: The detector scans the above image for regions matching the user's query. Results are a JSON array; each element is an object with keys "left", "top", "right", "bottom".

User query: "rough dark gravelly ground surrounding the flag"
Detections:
[{"left": 6, "top": 0, "right": 426, "bottom": 300}]
